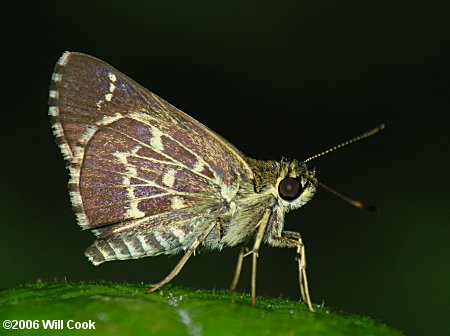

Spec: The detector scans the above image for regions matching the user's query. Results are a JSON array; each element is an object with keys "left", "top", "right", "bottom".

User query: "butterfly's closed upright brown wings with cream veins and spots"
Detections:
[{"left": 49, "top": 52, "right": 252, "bottom": 228}]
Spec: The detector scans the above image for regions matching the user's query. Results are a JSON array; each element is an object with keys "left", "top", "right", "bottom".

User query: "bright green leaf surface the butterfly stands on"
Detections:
[{"left": 0, "top": 282, "right": 401, "bottom": 336}]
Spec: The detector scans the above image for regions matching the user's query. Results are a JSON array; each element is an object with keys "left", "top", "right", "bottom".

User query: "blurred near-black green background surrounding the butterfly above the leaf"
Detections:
[{"left": 0, "top": 0, "right": 450, "bottom": 335}]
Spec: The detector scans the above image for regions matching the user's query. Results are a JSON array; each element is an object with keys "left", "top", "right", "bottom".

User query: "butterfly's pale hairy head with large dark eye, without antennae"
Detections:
[{"left": 277, "top": 159, "right": 317, "bottom": 211}]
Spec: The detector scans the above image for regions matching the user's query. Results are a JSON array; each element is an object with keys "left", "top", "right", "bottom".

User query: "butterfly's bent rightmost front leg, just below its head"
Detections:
[{"left": 272, "top": 231, "right": 315, "bottom": 313}]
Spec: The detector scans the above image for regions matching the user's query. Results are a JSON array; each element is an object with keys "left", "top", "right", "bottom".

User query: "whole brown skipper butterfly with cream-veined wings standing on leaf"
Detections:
[{"left": 49, "top": 52, "right": 383, "bottom": 311}]
